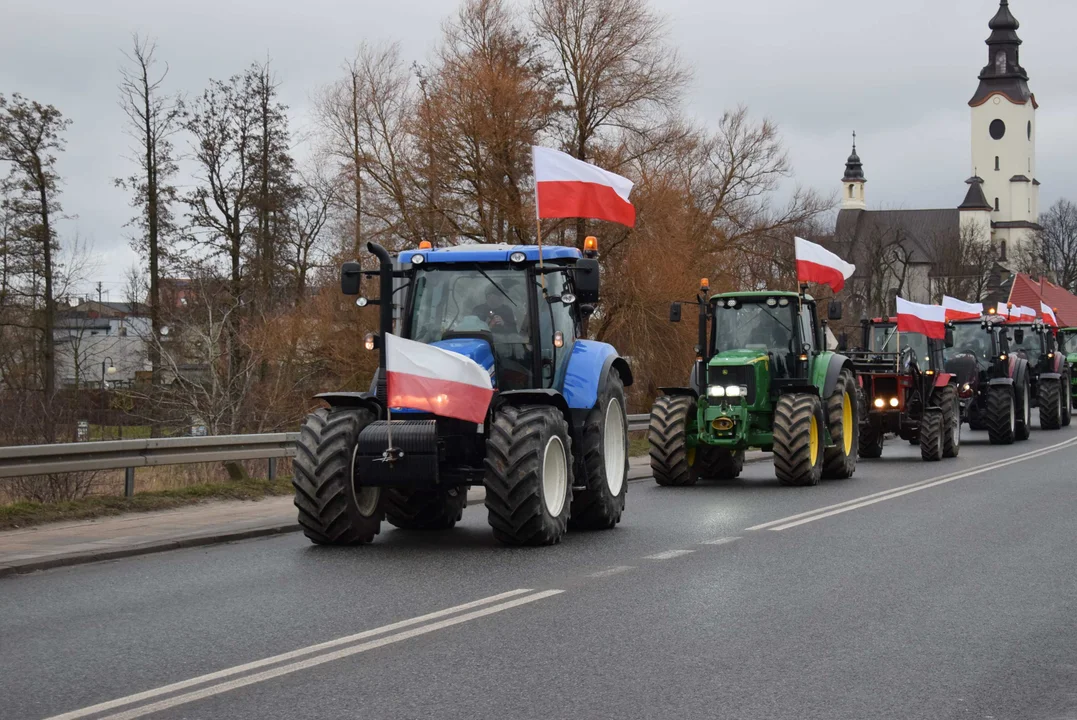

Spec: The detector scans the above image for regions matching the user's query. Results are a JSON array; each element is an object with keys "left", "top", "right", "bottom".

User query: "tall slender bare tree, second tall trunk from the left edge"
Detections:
[{"left": 116, "top": 34, "right": 184, "bottom": 383}]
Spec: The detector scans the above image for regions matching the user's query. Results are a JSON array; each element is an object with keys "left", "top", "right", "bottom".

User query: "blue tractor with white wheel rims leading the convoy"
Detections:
[{"left": 292, "top": 238, "right": 632, "bottom": 546}]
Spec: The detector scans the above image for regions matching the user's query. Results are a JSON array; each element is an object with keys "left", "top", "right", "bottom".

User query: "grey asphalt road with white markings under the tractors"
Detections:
[{"left": 0, "top": 426, "right": 1077, "bottom": 720}]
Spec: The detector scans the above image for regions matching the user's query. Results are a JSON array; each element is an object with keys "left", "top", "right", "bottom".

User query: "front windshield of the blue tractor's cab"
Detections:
[{"left": 410, "top": 266, "right": 529, "bottom": 343}]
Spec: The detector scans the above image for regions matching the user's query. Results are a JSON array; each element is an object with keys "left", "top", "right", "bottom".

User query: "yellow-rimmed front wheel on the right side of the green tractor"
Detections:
[{"left": 773, "top": 394, "right": 825, "bottom": 485}]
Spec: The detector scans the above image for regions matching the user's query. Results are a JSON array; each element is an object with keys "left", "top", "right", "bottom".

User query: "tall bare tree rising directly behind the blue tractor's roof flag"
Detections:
[{"left": 531, "top": 0, "right": 690, "bottom": 248}]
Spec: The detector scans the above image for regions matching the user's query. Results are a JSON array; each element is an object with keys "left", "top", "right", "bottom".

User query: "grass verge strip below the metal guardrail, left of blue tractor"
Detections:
[{"left": 0, "top": 479, "right": 292, "bottom": 531}]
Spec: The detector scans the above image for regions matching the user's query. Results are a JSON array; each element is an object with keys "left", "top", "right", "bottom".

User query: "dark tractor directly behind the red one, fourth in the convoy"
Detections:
[{"left": 943, "top": 312, "right": 1033, "bottom": 444}]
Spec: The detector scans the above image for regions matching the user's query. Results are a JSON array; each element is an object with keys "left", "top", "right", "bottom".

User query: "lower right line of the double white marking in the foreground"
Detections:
[{"left": 93, "top": 590, "right": 564, "bottom": 720}]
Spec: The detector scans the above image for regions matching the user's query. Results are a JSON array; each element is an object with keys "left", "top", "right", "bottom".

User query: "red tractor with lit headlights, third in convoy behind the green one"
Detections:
[{"left": 848, "top": 317, "right": 962, "bottom": 461}]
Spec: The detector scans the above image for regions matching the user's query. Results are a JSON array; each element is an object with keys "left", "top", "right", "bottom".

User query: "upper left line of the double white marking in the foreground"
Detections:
[{"left": 46, "top": 588, "right": 533, "bottom": 720}]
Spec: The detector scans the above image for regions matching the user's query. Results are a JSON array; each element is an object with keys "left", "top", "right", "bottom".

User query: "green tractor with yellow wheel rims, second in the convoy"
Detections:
[{"left": 648, "top": 281, "right": 859, "bottom": 485}]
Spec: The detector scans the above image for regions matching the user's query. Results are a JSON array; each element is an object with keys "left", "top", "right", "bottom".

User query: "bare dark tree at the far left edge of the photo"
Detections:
[{"left": 0, "top": 93, "right": 70, "bottom": 408}]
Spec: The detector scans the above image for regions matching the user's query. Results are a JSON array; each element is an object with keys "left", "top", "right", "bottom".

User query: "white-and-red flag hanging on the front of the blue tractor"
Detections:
[{"left": 384, "top": 334, "right": 493, "bottom": 423}]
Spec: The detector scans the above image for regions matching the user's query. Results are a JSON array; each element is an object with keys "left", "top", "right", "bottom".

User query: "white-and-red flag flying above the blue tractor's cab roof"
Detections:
[{"left": 531, "top": 146, "right": 635, "bottom": 227}]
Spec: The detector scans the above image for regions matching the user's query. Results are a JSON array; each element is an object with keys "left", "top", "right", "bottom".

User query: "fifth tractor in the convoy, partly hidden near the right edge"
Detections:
[{"left": 1009, "top": 320, "right": 1071, "bottom": 430}]
